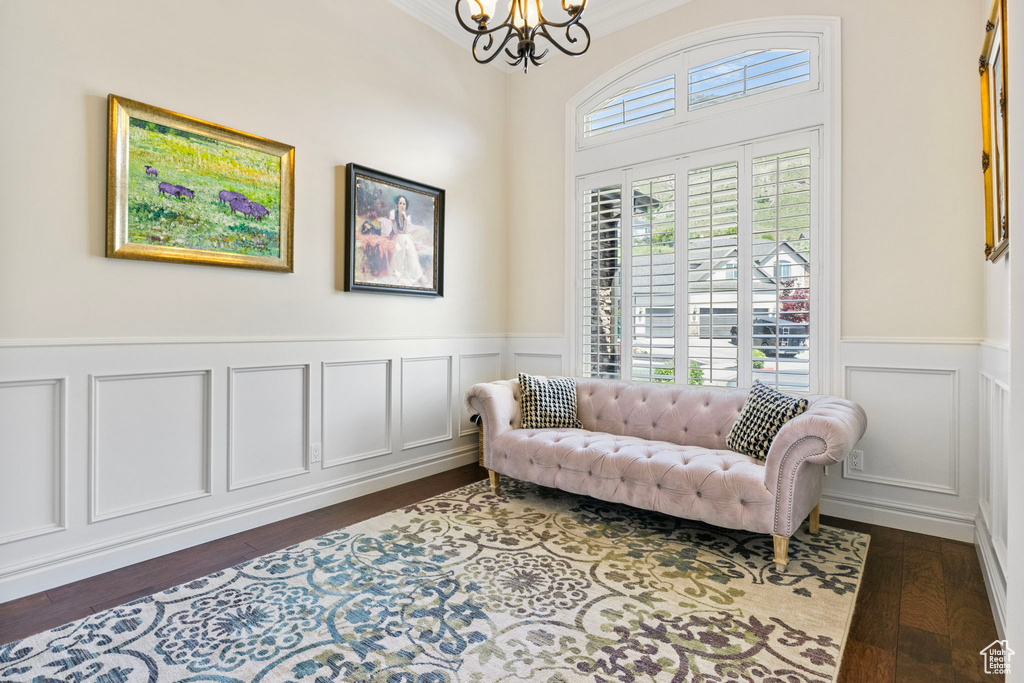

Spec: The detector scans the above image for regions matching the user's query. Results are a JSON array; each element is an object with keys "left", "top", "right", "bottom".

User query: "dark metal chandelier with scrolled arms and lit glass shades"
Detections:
[{"left": 455, "top": 0, "right": 590, "bottom": 73}]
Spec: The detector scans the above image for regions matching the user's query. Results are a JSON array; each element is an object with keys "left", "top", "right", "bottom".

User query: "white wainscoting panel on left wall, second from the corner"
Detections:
[{"left": 401, "top": 355, "right": 453, "bottom": 451}]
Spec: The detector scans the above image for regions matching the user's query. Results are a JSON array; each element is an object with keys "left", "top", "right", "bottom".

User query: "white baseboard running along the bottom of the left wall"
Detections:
[{"left": 0, "top": 443, "right": 477, "bottom": 602}]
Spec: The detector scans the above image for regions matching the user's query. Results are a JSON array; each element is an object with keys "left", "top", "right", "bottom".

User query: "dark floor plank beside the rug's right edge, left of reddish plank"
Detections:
[{"left": 850, "top": 548, "right": 903, "bottom": 652}]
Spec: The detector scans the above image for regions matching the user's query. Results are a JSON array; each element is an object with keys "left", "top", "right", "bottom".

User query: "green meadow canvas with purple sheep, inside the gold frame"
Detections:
[{"left": 128, "top": 118, "right": 281, "bottom": 257}]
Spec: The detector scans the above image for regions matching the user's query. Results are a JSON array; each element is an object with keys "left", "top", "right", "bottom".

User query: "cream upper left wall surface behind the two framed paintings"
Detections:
[{"left": 0, "top": 0, "right": 506, "bottom": 340}]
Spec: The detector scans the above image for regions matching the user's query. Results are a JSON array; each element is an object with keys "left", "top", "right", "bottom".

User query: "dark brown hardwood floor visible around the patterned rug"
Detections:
[{"left": 0, "top": 465, "right": 1002, "bottom": 683}]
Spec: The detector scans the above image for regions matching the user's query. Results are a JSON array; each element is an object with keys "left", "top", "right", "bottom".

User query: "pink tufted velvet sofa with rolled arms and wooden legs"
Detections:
[{"left": 466, "top": 379, "right": 867, "bottom": 566}]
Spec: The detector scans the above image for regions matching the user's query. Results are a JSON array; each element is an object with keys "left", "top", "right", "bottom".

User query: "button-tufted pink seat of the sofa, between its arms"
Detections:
[{"left": 492, "top": 429, "right": 775, "bottom": 533}]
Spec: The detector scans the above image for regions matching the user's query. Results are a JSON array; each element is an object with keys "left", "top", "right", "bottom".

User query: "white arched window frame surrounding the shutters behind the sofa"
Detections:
[{"left": 565, "top": 16, "right": 842, "bottom": 393}]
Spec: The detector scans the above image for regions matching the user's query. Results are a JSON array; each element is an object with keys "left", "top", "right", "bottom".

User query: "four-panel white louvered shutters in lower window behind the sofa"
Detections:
[{"left": 578, "top": 131, "right": 819, "bottom": 392}]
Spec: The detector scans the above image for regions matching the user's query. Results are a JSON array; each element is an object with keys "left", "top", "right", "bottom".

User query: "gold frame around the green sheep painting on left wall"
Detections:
[{"left": 106, "top": 94, "right": 295, "bottom": 272}]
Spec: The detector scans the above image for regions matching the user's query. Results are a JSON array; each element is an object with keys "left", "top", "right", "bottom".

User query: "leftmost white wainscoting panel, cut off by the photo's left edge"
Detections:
[{"left": 0, "top": 378, "right": 66, "bottom": 545}]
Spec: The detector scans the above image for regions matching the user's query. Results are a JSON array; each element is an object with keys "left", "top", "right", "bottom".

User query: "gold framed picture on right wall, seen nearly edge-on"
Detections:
[{"left": 978, "top": 0, "right": 1010, "bottom": 261}]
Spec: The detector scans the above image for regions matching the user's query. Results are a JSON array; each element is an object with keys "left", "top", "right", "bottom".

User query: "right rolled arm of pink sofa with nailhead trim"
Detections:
[{"left": 765, "top": 396, "right": 867, "bottom": 537}]
